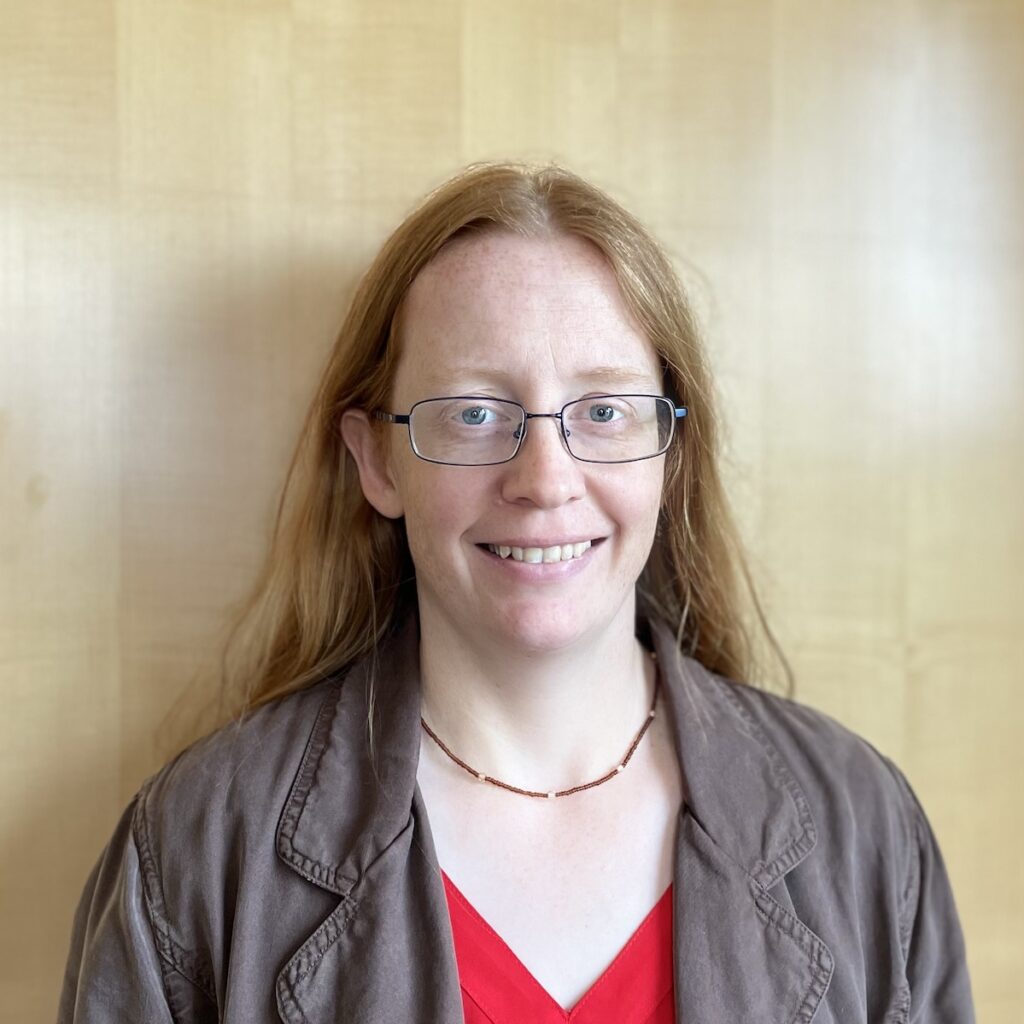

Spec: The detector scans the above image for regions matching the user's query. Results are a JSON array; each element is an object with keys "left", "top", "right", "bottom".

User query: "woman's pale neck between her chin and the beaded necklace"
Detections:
[{"left": 420, "top": 608, "right": 654, "bottom": 792}]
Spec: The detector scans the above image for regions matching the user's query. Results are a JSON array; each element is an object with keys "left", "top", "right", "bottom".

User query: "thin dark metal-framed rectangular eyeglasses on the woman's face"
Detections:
[{"left": 375, "top": 394, "right": 686, "bottom": 466}]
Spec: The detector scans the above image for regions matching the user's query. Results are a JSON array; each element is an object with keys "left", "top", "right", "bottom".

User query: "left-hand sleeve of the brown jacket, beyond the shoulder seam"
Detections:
[{"left": 57, "top": 797, "right": 176, "bottom": 1024}]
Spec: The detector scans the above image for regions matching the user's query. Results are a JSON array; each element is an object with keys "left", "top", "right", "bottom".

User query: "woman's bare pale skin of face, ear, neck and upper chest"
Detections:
[{"left": 342, "top": 233, "right": 682, "bottom": 1006}]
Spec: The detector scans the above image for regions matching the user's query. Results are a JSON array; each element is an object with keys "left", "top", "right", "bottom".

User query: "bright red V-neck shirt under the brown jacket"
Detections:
[{"left": 441, "top": 871, "right": 676, "bottom": 1024}]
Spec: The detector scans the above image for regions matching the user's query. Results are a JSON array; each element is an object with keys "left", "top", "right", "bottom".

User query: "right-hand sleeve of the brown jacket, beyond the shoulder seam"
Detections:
[{"left": 891, "top": 766, "right": 975, "bottom": 1024}]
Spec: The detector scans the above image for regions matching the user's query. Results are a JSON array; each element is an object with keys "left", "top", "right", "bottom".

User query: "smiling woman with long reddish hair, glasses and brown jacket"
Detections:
[{"left": 60, "top": 165, "right": 973, "bottom": 1024}]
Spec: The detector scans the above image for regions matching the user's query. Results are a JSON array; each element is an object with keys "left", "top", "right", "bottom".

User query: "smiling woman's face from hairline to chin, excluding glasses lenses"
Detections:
[{"left": 368, "top": 232, "right": 665, "bottom": 652}]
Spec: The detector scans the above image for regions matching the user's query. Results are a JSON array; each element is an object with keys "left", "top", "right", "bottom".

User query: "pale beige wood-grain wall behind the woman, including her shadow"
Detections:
[{"left": 0, "top": 0, "right": 1024, "bottom": 1024}]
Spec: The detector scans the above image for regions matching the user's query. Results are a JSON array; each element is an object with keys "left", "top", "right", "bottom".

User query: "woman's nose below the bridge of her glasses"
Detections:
[{"left": 502, "top": 417, "right": 587, "bottom": 508}]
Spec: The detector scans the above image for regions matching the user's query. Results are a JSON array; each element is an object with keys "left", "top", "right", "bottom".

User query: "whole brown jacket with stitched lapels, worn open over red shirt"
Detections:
[{"left": 58, "top": 621, "right": 974, "bottom": 1024}]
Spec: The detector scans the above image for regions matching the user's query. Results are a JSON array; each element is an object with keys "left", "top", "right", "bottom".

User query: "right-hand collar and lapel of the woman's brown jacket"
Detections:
[{"left": 651, "top": 623, "right": 833, "bottom": 1024}]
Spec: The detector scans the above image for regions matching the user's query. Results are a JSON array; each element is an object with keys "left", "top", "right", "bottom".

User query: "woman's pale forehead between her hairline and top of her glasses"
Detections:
[{"left": 395, "top": 231, "right": 660, "bottom": 396}]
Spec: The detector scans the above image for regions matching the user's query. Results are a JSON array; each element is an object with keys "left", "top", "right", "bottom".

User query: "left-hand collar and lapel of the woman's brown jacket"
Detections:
[{"left": 276, "top": 616, "right": 462, "bottom": 1024}]
